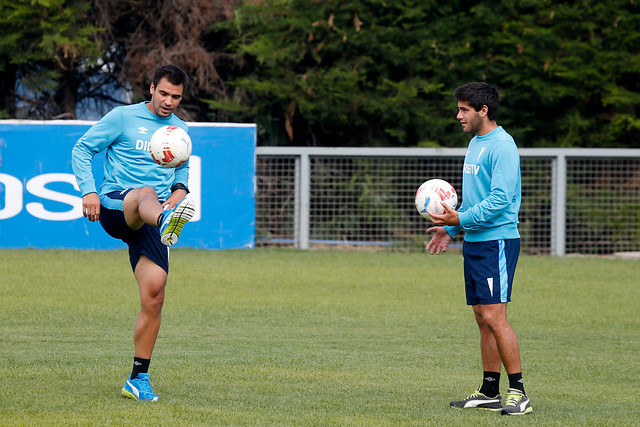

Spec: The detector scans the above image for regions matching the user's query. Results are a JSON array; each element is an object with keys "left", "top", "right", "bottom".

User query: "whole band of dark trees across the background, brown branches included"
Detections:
[{"left": 0, "top": 0, "right": 640, "bottom": 147}]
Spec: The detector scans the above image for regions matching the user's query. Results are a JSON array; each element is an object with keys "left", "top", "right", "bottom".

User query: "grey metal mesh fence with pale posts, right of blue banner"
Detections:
[{"left": 256, "top": 147, "right": 640, "bottom": 255}]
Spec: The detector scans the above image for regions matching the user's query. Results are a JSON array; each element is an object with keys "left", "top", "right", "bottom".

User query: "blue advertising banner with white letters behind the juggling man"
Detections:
[{"left": 0, "top": 120, "right": 256, "bottom": 249}]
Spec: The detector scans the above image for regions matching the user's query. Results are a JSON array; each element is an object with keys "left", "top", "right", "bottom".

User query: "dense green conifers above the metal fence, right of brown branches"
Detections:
[{"left": 210, "top": 0, "right": 640, "bottom": 146}]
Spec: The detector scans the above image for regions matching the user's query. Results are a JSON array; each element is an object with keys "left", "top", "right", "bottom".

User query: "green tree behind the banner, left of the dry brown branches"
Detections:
[{"left": 0, "top": 0, "right": 100, "bottom": 118}]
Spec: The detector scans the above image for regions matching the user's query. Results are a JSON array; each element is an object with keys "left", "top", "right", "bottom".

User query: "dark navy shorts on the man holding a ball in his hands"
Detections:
[{"left": 462, "top": 239, "right": 520, "bottom": 305}]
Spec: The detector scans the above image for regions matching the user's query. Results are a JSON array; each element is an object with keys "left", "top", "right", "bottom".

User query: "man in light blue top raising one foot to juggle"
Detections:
[{"left": 72, "top": 65, "right": 194, "bottom": 401}]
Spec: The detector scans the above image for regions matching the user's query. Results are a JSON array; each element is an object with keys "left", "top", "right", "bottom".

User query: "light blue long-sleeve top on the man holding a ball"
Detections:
[{"left": 445, "top": 126, "right": 522, "bottom": 242}]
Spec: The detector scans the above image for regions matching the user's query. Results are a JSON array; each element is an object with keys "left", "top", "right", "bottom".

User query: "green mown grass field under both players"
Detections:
[{"left": 0, "top": 249, "right": 640, "bottom": 426}]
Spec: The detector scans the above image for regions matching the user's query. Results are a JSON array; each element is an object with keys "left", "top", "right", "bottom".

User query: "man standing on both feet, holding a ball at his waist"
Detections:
[{"left": 427, "top": 82, "right": 533, "bottom": 415}]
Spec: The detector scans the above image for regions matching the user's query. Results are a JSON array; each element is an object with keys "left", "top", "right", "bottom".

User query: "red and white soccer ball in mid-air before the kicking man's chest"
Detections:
[{"left": 149, "top": 126, "right": 191, "bottom": 168}]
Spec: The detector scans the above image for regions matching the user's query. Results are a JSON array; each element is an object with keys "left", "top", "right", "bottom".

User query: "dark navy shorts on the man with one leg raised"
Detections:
[{"left": 100, "top": 189, "right": 169, "bottom": 274}]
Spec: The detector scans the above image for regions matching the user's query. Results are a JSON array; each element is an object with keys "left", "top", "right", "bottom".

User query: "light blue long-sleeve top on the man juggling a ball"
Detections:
[{"left": 71, "top": 102, "right": 189, "bottom": 206}]
